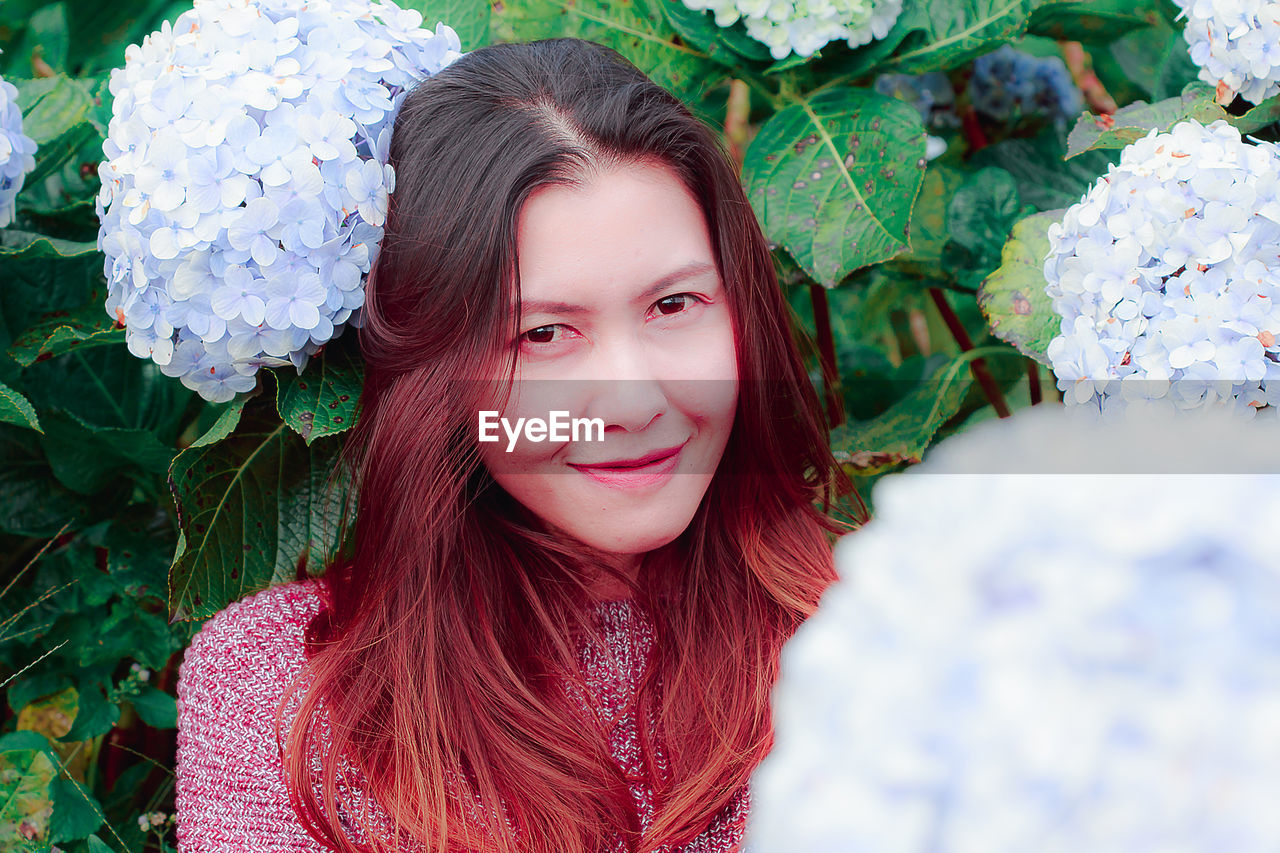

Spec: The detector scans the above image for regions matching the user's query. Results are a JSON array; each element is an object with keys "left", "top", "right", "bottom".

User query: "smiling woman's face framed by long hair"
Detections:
[{"left": 477, "top": 164, "right": 737, "bottom": 565}]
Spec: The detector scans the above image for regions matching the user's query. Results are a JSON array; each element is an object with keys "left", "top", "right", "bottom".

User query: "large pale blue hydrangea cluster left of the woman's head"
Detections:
[{"left": 97, "top": 0, "right": 462, "bottom": 402}]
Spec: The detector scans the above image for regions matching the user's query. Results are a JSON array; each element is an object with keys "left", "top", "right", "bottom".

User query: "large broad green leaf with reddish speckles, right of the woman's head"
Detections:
[{"left": 742, "top": 87, "right": 925, "bottom": 287}]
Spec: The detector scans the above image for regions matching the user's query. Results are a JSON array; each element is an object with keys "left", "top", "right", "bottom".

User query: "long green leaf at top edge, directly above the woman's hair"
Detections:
[{"left": 490, "top": 0, "right": 728, "bottom": 119}]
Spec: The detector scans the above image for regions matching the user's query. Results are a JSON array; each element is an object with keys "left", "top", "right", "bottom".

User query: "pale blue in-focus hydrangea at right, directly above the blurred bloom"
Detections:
[{"left": 1044, "top": 120, "right": 1280, "bottom": 416}]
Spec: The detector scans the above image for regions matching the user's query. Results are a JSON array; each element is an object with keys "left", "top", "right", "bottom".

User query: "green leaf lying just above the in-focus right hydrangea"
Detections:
[{"left": 1066, "top": 81, "right": 1280, "bottom": 158}]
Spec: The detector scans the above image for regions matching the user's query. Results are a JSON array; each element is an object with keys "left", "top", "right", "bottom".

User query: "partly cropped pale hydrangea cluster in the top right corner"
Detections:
[{"left": 1174, "top": 0, "right": 1280, "bottom": 104}]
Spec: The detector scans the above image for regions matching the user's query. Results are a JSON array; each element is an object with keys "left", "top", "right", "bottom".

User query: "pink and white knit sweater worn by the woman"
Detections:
[{"left": 175, "top": 579, "right": 750, "bottom": 853}]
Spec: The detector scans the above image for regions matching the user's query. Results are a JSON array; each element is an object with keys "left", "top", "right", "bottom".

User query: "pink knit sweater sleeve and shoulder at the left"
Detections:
[{"left": 175, "top": 579, "right": 326, "bottom": 853}]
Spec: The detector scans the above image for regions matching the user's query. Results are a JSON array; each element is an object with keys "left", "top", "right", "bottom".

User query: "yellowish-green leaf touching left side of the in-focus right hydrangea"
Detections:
[{"left": 978, "top": 210, "right": 1065, "bottom": 366}]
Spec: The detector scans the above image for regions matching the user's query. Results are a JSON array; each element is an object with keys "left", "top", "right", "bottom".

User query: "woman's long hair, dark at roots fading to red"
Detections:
[{"left": 276, "top": 38, "right": 856, "bottom": 853}]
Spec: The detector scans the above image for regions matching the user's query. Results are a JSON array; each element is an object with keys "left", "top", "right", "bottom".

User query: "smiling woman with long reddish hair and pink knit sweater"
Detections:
[{"left": 178, "top": 38, "right": 850, "bottom": 853}]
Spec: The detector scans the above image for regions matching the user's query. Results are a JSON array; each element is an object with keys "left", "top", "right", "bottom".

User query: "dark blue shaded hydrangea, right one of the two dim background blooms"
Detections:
[{"left": 968, "top": 45, "right": 1084, "bottom": 122}]
